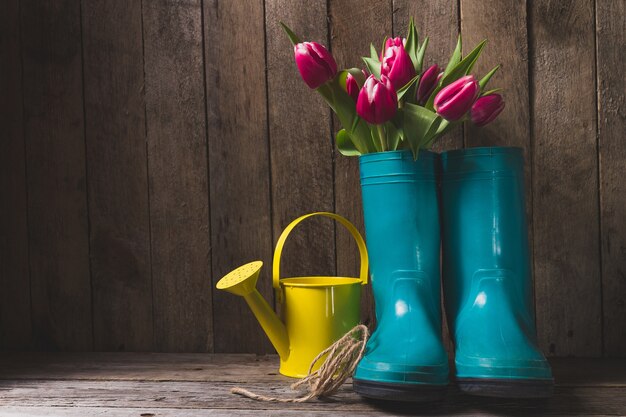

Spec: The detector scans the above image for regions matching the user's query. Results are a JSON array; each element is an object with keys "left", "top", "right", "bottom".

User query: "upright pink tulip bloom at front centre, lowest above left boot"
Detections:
[{"left": 356, "top": 75, "right": 398, "bottom": 125}]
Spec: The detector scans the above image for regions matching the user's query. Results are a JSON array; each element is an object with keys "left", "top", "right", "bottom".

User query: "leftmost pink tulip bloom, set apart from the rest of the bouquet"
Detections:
[{"left": 293, "top": 42, "right": 337, "bottom": 89}]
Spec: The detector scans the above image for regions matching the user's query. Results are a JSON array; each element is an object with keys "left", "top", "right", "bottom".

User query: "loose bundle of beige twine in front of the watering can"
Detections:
[{"left": 230, "top": 324, "right": 369, "bottom": 403}]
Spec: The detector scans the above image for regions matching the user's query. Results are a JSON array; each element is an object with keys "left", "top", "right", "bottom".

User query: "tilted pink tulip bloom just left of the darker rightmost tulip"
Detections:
[{"left": 434, "top": 75, "right": 480, "bottom": 122}]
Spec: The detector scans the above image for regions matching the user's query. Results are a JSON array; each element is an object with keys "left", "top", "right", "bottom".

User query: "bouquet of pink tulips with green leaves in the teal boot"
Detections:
[{"left": 281, "top": 19, "right": 504, "bottom": 159}]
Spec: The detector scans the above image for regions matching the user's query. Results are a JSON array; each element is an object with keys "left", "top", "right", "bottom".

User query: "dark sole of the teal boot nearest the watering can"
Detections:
[{"left": 352, "top": 379, "right": 448, "bottom": 402}]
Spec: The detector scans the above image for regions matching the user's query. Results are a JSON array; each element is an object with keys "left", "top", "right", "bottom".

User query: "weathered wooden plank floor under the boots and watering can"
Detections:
[{"left": 0, "top": 353, "right": 626, "bottom": 417}]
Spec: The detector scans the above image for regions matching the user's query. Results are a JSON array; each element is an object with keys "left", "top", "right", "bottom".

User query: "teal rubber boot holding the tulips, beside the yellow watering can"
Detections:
[{"left": 353, "top": 151, "right": 449, "bottom": 401}]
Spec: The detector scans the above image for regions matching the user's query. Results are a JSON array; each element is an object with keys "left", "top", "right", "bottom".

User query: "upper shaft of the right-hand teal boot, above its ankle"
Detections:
[{"left": 441, "top": 147, "right": 534, "bottom": 322}]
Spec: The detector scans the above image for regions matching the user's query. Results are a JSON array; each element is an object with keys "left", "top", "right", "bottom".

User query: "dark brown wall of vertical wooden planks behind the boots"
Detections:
[{"left": 0, "top": 0, "right": 626, "bottom": 356}]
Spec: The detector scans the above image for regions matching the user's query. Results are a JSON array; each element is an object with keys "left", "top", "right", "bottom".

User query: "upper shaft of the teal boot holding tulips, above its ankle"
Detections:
[{"left": 360, "top": 151, "right": 440, "bottom": 316}]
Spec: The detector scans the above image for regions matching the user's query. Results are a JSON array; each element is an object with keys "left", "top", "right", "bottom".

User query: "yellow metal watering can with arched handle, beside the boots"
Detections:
[{"left": 216, "top": 212, "right": 368, "bottom": 378}]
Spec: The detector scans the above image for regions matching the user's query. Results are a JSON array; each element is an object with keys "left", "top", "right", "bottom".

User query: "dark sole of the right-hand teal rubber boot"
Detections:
[{"left": 456, "top": 378, "right": 554, "bottom": 398}]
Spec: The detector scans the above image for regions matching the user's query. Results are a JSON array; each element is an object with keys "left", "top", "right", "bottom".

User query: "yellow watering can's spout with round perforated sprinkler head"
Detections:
[{"left": 216, "top": 261, "right": 289, "bottom": 360}]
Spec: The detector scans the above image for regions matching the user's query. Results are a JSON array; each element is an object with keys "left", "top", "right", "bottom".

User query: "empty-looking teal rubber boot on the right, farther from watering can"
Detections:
[{"left": 441, "top": 147, "right": 554, "bottom": 398}]
